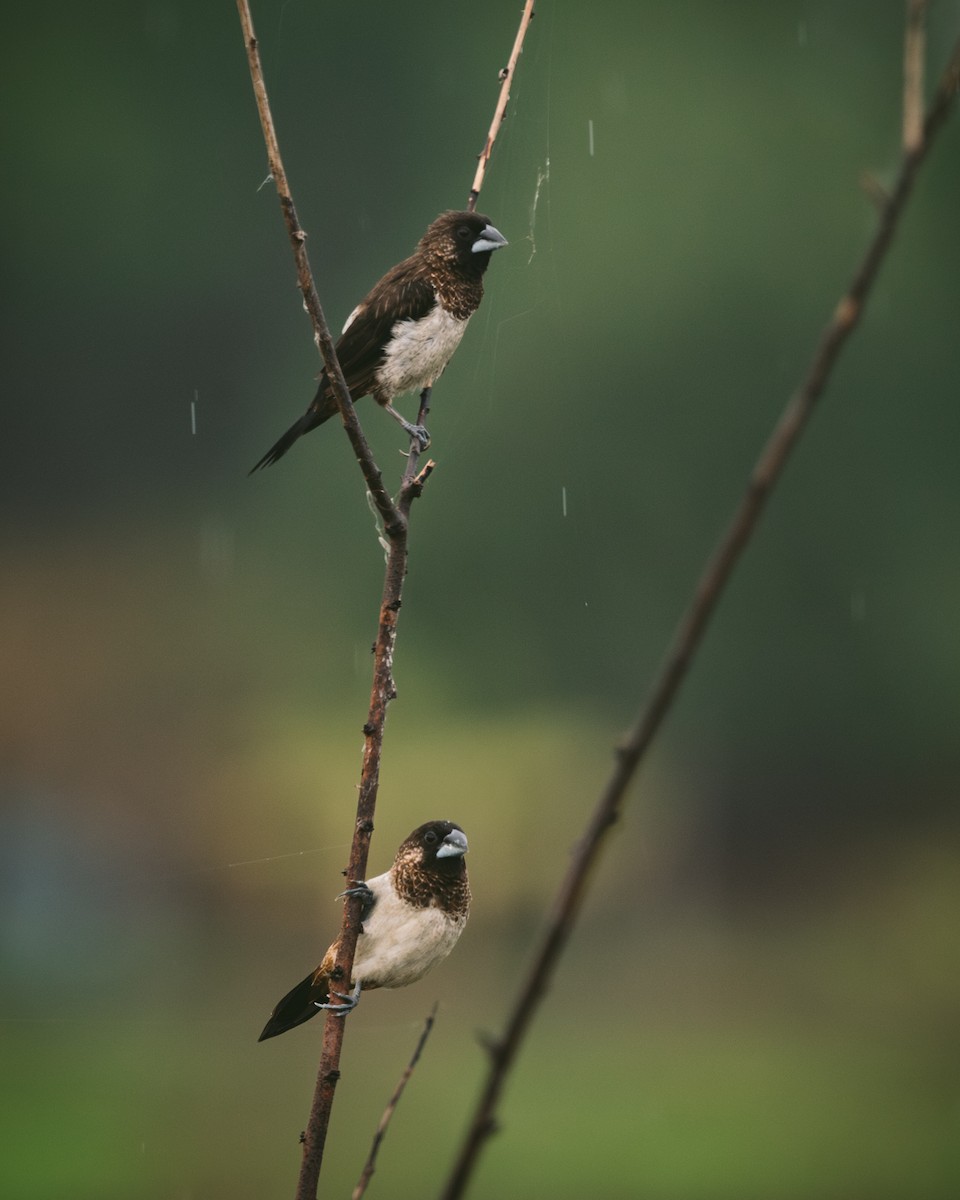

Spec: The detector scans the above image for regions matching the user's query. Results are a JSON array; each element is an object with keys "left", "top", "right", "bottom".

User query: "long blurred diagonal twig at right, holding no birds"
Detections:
[{"left": 440, "top": 28, "right": 960, "bottom": 1200}]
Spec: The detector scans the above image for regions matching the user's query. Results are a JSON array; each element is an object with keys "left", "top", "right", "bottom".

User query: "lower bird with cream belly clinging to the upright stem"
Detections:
[{"left": 258, "top": 821, "right": 470, "bottom": 1042}]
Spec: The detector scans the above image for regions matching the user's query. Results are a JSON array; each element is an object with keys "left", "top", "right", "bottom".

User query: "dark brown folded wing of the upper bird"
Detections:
[{"left": 337, "top": 257, "right": 437, "bottom": 401}]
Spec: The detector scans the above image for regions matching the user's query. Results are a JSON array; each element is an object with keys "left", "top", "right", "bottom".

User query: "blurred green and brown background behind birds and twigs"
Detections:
[{"left": 0, "top": 0, "right": 960, "bottom": 1200}]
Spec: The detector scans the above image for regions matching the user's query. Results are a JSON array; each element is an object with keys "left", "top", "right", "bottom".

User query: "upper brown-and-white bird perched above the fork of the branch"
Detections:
[{"left": 250, "top": 211, "right": 508, "bottom": 475}]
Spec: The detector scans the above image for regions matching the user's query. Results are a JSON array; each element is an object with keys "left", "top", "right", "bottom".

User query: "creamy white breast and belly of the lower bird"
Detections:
[{"left": 353, "top": 876, "right": 466, "bottom": 988}]
